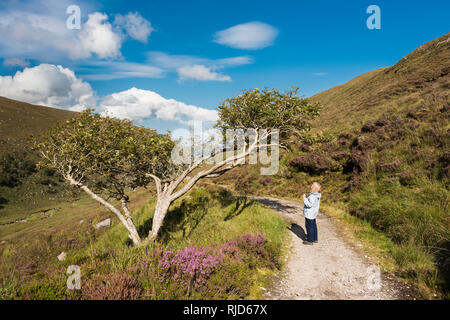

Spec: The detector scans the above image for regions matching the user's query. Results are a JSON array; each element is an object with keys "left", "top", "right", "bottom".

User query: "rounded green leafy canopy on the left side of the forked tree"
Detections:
[{"left": 37, "top": 110, "right": 174, "bottom": 199}]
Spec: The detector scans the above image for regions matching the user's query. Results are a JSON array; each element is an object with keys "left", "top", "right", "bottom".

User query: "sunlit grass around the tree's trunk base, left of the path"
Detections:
[{"left": 0, "top": 188, "right": 287, "bottom": 299}]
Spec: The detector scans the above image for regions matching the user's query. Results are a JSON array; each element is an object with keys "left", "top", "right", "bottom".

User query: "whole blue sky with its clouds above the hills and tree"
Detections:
[{"left": 0, "top": 0, "right": 450, "bottom": 131}]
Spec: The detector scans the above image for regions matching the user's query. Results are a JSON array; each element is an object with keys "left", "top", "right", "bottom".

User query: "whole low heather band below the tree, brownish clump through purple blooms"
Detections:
[{"left": 81, "top": 233, "right": 279, "bottom": 300}]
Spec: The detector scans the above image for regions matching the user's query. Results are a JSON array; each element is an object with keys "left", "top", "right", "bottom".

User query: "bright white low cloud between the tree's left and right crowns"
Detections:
[{"left": 100, "top": 88, "right": 218, "bottom": 124}]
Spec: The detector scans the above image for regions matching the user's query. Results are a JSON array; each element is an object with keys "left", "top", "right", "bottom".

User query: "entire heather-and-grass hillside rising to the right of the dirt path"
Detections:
[{"left": 215, "top": 34, "right": 450, "bottom": 298}]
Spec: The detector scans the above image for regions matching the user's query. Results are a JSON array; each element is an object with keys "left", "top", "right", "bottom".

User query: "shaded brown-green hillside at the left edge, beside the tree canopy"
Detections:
[{"left": 0, "top": 97, "right": 77, "bottom": 224}]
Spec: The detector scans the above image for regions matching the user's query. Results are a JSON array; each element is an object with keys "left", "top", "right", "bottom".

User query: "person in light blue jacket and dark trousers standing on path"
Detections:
[{"left": 303, "top": 182, "right": 322, "bottom": 245}]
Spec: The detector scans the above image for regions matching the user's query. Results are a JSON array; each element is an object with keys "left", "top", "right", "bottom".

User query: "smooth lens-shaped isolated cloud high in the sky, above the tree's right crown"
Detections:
[{"left": 214, "top": 22, "right": 278, "bottom": 50}]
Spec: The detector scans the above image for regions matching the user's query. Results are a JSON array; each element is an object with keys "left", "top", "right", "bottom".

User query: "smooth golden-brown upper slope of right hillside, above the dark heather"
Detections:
[{"left": 311, "top": 33, "right": 450, "bottom": 132}]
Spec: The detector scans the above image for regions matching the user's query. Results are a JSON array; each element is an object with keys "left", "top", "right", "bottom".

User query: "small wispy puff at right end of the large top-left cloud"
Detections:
[{"left": 114, "top": 12, "right": 155, "bottom": 43}]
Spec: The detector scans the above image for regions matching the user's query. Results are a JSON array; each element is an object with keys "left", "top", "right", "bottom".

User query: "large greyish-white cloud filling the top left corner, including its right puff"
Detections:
[{"left": 0, "top": 0, "right": 153, "bottom": 61}]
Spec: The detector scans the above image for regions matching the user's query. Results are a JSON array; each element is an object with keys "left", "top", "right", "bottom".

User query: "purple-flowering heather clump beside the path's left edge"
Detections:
[{"left": 139, "top": 234, "right": 279, "bottom": 299}]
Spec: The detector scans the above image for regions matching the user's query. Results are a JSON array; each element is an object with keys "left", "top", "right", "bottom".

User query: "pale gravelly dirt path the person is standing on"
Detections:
[{"left": 250, "top": 197, "right": 401, "bottom": 300}]
